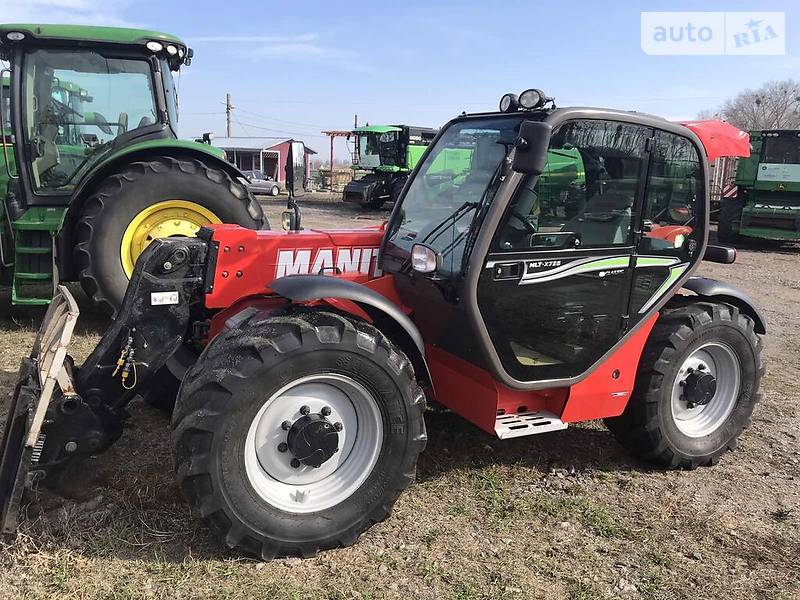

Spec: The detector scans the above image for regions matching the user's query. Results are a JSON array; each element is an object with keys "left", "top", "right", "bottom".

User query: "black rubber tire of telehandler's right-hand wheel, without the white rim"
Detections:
[{"left": 605, "top": 301, "right": 764, "bottom": 469}]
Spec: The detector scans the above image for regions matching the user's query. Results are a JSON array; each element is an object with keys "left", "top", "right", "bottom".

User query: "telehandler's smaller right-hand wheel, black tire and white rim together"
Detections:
[{"left": 605, "top": 302, "right": 764, "bottom": 469}]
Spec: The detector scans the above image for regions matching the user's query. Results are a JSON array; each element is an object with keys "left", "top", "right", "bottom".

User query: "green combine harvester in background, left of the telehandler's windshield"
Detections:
[{"left": 344, "top": 125, "right": 436, "bottom": 209}]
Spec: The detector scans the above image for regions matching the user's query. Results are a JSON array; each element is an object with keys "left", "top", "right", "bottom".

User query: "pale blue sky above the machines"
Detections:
[{"left": 0, "top": 0, "right": 800, "bottom": 158}]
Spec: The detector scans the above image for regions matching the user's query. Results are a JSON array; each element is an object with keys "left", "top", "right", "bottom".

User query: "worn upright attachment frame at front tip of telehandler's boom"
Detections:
[{"left": 0, "top": 285, "right": 79, "bottom": 533}]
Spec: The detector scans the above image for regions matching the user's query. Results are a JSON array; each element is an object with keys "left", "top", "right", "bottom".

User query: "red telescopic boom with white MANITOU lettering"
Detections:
[{"left": 205, "top": 225, "right": 383, "bottom": 308}]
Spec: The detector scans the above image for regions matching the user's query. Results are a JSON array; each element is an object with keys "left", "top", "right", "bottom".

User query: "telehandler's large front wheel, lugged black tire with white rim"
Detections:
[{"left": 172, "top": 312, "right": 427, "bottom": 560}]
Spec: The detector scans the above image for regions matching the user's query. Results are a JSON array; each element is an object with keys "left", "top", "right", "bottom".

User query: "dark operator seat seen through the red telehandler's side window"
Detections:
[{"left": 561, "top": 183, "right": 633, "bottom": 246}]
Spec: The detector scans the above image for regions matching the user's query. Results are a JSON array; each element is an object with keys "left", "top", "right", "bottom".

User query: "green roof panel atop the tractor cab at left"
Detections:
[{"left": 0, "top": 23, "right": 186, "bottom": 47}]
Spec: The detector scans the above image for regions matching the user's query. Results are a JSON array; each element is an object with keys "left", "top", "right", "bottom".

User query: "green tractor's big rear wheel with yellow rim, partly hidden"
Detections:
[{"left": 75, "top": 156, "right": 269, "bottom": 314}]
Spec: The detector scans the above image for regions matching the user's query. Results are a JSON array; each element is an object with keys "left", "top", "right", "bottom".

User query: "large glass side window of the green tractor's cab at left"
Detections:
[{"left": 24, "top": 50, "right": 157, "bottom": 193}]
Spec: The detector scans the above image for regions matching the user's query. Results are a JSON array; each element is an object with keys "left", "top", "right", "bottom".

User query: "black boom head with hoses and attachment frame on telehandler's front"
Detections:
[{"left": 0, "top": 238, "right": 208, "bottom": 533}]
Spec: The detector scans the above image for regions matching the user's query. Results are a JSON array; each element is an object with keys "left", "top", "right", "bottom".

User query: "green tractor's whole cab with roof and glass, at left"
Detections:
[{"left": 0, "top": 24, "right": 191, "bottom": 198}]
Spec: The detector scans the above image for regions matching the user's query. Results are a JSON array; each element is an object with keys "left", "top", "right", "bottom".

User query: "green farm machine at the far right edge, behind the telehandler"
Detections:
[{"left": 717, "top": 130, "right": 800, "bottom": 242}]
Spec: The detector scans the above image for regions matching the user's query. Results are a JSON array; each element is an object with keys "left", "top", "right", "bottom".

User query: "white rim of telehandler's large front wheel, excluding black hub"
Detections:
[{"left": 244, "top": 374, "right": 383, "bottom": 513}]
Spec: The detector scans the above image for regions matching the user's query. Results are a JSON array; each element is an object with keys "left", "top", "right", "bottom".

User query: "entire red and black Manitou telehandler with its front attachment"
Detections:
[{"left": 0, "top": 90, "right": 765, "bottom": 559}]
